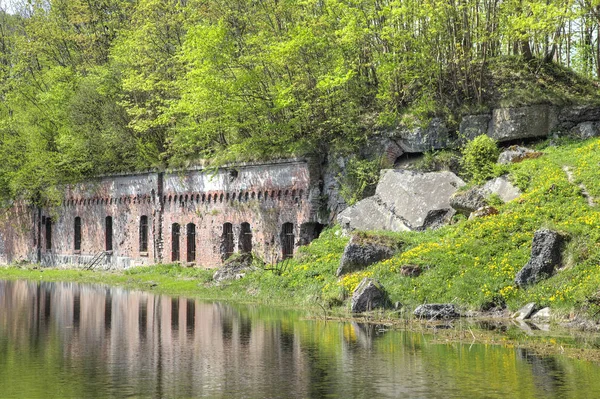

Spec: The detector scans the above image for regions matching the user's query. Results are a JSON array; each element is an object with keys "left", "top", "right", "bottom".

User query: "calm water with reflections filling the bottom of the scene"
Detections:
[{"left": 0, "top": 281, "right": 600, "bottom": 399}]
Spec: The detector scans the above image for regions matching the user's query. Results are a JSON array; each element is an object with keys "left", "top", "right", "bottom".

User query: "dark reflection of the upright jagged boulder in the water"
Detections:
[{"left": 516, "top": 348, "right": 565, "bottom": 398}]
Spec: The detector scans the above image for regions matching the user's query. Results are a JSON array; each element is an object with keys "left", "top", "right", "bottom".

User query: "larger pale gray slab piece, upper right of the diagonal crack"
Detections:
[{"left": 375, "top": 169, "right": 465, "bottom": 230}]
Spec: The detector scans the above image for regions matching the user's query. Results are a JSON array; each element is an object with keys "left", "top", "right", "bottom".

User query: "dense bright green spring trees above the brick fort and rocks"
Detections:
[{"left": 0, "top": 0, "right": 600, "bottom": 205}]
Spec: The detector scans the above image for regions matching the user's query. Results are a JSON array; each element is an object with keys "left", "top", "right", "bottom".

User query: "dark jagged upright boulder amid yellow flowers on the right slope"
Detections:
[{"left": 515, "top": 229, "right": 564, "bottom": 287}]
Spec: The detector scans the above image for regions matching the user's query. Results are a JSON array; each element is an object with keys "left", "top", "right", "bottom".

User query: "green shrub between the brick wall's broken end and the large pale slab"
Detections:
[{"left": 337, "top": 157, "right": 381, "bottom": 205}]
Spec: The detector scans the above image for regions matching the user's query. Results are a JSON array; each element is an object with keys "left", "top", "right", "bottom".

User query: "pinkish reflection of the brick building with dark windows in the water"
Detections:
[{"left": 0, "top": 281, "right": 308, "bottom": 397}]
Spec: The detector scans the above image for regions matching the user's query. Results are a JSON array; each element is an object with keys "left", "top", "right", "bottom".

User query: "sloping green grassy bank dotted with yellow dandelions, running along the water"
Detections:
[{"left": 0, "top": 139, "right": 600, "bottom": 317}]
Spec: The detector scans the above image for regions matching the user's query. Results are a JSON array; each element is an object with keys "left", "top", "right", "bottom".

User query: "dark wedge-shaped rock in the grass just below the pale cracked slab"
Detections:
[{"left": 336, "top": 236, "right": 396, "bottom": 277}]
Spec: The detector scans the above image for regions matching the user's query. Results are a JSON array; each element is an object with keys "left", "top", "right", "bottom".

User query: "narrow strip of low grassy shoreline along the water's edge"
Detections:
[{"left": 0, "top": 266, "right": 600, "bottom": 362}]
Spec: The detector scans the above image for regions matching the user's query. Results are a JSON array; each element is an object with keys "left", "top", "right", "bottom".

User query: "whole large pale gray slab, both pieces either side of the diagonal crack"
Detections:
[{"left": 338, "top": 169, "right": 465, "bottom": 231}]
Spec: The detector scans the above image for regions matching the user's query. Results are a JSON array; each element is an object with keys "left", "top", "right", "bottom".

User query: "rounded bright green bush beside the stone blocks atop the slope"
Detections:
[{"left": 461, "top": 135, "right": 500, "bottom": 184}]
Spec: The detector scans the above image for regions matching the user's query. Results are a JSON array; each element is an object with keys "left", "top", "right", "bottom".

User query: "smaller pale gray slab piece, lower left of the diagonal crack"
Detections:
[{"left": 337, "top": 196, "right": 410, "bottom": 232}]
